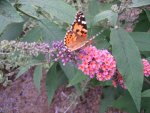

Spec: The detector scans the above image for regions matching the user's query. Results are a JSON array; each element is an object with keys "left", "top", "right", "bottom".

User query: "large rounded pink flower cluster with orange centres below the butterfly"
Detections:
[{"left": 78, "top": 46, "right": 116, "bottom": 81}]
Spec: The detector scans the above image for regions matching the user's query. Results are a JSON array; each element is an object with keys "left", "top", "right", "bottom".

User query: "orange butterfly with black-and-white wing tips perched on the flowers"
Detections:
[{"left": 64, "top": 11, "right": 100, "bottom": 52}]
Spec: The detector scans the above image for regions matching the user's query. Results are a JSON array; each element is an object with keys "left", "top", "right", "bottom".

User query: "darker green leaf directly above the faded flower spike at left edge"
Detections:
[{"left": 0, "top": 22, "right": 24, "bottom": 40}]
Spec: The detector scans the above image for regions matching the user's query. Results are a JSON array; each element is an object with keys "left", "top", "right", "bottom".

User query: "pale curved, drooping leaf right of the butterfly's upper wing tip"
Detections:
[{"left": 94, "top": 10, "right": 118, "bottom": 26}]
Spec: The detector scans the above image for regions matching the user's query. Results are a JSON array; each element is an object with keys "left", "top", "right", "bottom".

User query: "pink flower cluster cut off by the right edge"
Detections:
[{"left": 142, "top": 59, "right": 150, "bottom": 77}]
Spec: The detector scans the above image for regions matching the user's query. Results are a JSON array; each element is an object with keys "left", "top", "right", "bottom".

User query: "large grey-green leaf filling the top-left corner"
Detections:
[{"left": 0, "top": 0, "right": 23, "bottom": 34}]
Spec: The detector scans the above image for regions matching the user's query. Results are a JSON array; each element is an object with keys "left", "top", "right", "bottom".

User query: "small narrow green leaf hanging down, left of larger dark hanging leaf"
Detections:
[{"left": 33, "top": 65, "right": 42, "bottom": 92}]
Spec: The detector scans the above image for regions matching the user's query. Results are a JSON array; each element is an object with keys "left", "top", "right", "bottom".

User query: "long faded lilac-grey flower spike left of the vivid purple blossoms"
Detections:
[{"left": 0, "top": 40, "right": 50, "bottom": 56}]
